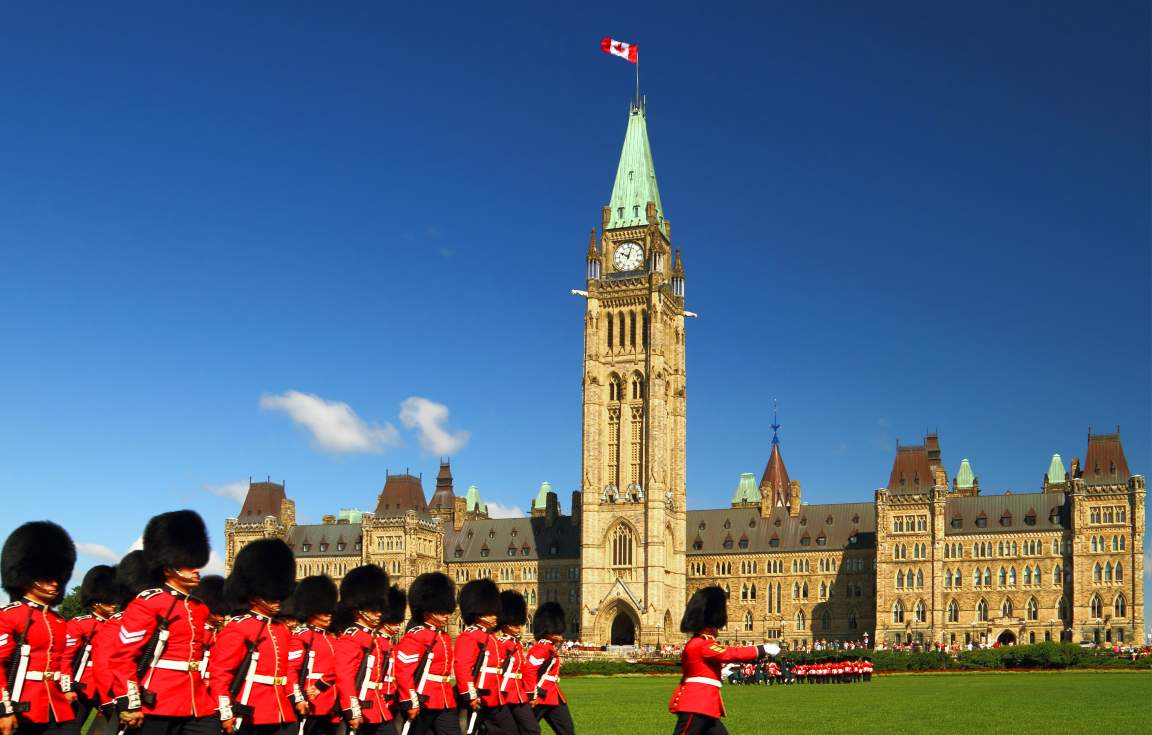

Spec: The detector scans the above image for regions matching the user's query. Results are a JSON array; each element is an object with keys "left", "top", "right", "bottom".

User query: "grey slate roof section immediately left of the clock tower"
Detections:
[{"left": 444, "top": 516, "right": 579, "bottom": 562}]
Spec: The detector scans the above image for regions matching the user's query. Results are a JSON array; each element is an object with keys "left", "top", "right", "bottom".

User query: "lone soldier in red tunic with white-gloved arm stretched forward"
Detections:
[{"left": 668, "top": 586, "right": 780, "bottom": 735}]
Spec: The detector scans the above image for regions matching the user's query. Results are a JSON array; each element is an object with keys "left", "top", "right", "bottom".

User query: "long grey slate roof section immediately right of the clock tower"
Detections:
[{"left": 687, "top": 502, "right": 876, "bottom": 556}]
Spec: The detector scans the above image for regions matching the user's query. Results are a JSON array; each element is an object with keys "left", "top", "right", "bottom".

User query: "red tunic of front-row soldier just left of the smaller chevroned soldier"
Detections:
[{"left": 334, "top": 624, "right": 393, "bottom": 723}]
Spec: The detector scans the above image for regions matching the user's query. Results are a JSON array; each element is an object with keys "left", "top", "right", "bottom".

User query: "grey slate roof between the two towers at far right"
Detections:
[{"left": 943, "top": 493, "right": 1069, "bottom": 536}]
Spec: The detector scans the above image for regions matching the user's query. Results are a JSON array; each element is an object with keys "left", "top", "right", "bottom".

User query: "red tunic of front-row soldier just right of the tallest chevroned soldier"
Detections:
[{"left": 212, "top": 613, "right": 300, "bottom": 725}]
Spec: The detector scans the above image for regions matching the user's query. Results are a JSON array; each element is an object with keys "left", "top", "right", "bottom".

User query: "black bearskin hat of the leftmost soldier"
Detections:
[{"left": 0, "top": 521, "right": 76, "bottom": 600}]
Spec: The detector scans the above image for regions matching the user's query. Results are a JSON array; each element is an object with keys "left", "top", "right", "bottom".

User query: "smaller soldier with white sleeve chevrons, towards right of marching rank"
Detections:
[{"left": 396, "top": 571, "right": 460, "bottom": 735}]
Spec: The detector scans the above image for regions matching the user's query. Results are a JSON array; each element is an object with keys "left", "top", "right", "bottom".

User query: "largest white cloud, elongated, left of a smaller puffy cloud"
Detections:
[{"left": 260, "top": 391, "right": 401, "bottom": 454}]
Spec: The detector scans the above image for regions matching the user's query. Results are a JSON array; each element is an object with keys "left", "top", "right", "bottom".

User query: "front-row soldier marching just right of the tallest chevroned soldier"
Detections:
[{"left": 212, "top": 538, "right": 308, "bottom": 735}]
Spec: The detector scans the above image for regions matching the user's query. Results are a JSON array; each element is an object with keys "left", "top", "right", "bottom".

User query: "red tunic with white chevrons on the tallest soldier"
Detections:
[{"left": 108, "top": 586, "right": 215, "bottom": 718}]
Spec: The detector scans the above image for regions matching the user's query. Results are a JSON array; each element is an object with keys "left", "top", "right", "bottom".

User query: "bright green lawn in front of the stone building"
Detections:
[{"left": 557, "top": 672, "right": 1152, "bottom": 735}]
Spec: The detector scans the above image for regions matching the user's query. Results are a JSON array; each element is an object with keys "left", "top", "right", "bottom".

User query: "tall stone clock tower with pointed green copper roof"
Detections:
[{"left": 579, "top": 101, "right": 685, "bottom": 645}]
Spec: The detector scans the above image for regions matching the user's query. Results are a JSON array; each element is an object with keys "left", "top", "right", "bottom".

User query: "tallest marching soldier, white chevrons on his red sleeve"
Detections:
[{"left": 108, "top": 510, "right": 220, "bottom": 735}]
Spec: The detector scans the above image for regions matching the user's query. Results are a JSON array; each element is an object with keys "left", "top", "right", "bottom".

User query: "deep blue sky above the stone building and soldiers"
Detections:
[{"left": 0, "top": 2, "right": 1152, "bottom": 622}]
